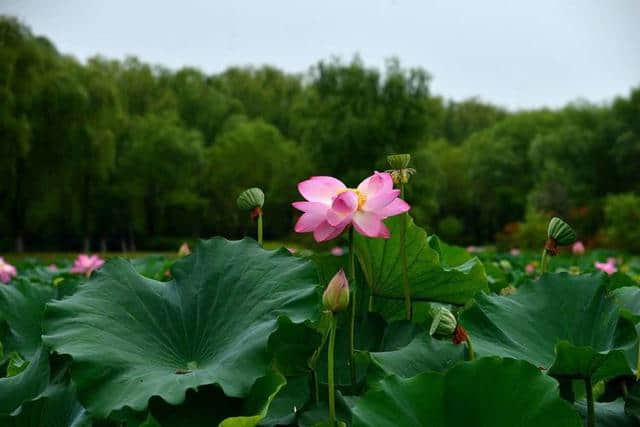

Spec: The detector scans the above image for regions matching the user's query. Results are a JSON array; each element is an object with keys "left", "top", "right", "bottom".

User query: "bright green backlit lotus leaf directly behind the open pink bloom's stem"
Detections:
[{"left": 355, "top": 215, "right": 488, "bottom": 317}]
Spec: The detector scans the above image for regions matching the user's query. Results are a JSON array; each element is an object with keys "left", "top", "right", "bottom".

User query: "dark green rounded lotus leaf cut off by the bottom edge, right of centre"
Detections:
[{"left": 353, "top": 357, "right": 582, "bottom": 427}]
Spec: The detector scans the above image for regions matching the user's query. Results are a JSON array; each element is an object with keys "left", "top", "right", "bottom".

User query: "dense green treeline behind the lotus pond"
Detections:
[{"left": 0, "top": 17, "right": 640, "bottom": 250}]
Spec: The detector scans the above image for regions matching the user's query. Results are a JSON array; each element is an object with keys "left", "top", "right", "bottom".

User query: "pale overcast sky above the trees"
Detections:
[{"left": 0, "top": 0, "right": 640, "bottom": 109}]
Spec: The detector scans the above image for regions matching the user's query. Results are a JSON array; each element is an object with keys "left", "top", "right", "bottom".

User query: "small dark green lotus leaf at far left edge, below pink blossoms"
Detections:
[{"left": 0, "top": 280, "right": 57, "bottom": 359}]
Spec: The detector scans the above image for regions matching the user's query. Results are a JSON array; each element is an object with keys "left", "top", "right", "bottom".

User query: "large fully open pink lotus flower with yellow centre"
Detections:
[{"left": 293, "top": 172, "right": 410, "bottom": 242}]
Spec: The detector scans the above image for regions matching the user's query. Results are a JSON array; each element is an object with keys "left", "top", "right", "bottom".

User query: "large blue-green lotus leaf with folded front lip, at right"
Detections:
[{"left": 460, "top": 273, "right": 637, "bottom": 382}]
